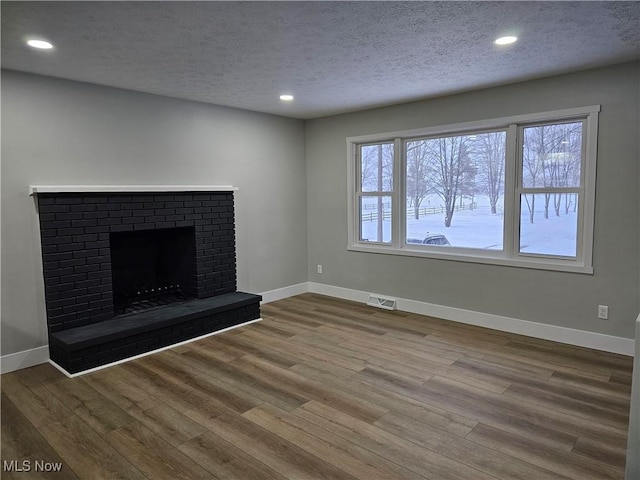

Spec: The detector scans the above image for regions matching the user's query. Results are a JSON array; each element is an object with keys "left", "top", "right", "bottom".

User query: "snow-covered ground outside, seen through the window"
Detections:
[{"left": 362, "top": 195, "right": 577, "bottom": 257}]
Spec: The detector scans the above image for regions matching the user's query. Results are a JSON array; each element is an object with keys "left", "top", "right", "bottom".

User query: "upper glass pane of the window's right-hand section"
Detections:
[{"left": 522, "top": 122, "right": 582, "bottom": 188}]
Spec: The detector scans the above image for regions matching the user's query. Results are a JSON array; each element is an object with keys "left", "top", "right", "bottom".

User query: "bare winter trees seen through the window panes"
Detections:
[{"left": 361, "top": 122, "right": 582, "bottom": 228}]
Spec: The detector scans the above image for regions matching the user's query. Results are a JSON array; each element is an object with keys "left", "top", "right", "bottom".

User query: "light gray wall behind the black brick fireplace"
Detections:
[{"left": 1, "top": 71, "right": 307, "bottom": 355}]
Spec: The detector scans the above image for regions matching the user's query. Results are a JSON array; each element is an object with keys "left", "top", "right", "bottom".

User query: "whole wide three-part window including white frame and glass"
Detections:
[{"left": 347, "top": 106, "right": 600, "bottom": 273}]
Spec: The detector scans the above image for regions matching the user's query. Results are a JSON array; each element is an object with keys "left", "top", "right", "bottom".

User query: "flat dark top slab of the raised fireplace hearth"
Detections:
[{"left": 50, "top": 292, "right": 262, "bottom": 351}]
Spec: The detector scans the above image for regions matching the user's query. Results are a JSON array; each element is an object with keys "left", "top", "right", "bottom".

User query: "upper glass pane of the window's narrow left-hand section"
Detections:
[{"left": 360, "top": 143, "right": 394, "bottom": 192}]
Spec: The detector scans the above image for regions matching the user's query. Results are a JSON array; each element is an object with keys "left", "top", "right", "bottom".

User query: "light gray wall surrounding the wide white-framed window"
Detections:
[{"left": 306, "top": 62, "right": 640, "bottom": 338}]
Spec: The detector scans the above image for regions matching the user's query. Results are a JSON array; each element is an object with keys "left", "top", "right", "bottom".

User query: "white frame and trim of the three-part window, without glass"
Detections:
[{"left": 347, "top": 105, "right": 600, "bottom": 274}]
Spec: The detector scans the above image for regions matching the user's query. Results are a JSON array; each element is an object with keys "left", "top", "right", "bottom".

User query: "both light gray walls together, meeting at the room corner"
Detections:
[{"left": 0, "top": 62, "right": 640, "bottom": 355}]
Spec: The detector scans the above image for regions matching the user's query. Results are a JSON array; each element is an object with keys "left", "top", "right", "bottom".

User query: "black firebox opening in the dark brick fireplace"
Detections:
[{"left": 109, "top": 227, "right": 196, "bottom": 315}]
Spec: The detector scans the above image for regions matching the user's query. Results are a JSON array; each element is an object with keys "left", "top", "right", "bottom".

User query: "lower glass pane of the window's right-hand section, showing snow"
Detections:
[{"left": 520, "top": 193, "right": 578, "bottom": 257}]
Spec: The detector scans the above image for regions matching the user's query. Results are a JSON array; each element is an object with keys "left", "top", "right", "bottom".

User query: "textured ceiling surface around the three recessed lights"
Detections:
[{"left": 1, "top": 1, "right": 640, "bottom": 118}]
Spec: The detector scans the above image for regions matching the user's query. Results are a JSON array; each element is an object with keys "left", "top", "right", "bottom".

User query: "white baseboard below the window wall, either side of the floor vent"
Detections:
[{"left": 309, "top": 282, "right": 635, "bottom": 356}]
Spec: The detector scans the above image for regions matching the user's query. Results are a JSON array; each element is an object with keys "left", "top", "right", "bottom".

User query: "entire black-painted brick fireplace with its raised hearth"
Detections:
[{"left": 33, "top": 187, "right": 261, "bottom": 373}]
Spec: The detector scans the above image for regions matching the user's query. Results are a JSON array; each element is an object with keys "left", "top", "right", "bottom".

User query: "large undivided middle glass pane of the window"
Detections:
[{"left": 405, "top": 131, "right": 506, "bottom": 250}]
